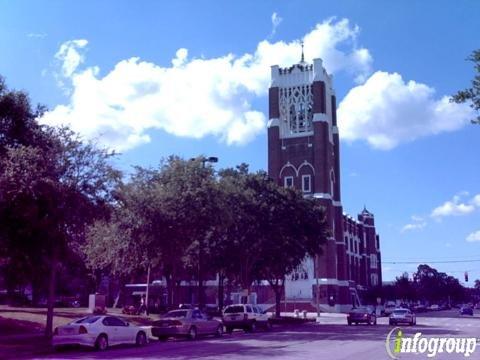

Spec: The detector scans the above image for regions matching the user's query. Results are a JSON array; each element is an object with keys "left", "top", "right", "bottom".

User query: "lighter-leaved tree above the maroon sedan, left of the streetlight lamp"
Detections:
[{"left": 85, "top": 156, "right": 223, "bottom": 305}]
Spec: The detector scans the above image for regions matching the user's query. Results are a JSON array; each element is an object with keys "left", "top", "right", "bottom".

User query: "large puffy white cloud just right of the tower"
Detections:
[{"left": 338, "top": 71, "right": 472, "bottom": 150}]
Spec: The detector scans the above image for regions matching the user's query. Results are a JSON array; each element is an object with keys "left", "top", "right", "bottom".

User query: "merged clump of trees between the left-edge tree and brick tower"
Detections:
[{"left": 85, "top": 162, "right": 326, "bottom": 311}]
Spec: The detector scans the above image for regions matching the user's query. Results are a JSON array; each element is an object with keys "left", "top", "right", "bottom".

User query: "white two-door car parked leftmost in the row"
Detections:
[{"left": 52, "top": 315, "right": 148, "bottom": 350}]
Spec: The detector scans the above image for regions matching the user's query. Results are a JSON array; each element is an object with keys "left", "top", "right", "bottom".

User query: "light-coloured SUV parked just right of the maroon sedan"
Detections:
[{"left": 222, "top": 304, "right": 272, "bottom": 333}]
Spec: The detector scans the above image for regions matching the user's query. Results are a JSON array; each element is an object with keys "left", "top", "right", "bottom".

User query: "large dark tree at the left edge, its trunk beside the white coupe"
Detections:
[{"left": 0, "top": 77, "right": 120, "bottom": 335}]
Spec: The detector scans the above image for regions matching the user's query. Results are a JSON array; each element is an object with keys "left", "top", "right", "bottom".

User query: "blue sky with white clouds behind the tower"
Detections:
[{"left": 0, "top": 0, "right": 480, "bottom": 286}]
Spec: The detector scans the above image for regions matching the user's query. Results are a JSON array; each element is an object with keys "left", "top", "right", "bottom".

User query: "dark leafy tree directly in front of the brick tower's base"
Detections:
[{"left": 218, "top": 164, "right": 327, "bottom": 315}]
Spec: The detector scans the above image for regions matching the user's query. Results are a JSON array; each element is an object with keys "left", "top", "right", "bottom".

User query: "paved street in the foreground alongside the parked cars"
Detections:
[{"left": 35, "top": 311, "right": 480, "bottom": 360}]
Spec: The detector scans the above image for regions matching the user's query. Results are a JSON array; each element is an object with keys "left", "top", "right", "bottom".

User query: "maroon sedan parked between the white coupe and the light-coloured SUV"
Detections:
[{"left": 152, "top": 309, "right": 223, "bottom": 340}]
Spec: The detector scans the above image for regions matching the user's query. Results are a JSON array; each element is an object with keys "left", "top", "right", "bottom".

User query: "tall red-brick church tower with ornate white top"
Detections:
[{"left": 268, "top": 54, "right": 375, "bottom": 311}]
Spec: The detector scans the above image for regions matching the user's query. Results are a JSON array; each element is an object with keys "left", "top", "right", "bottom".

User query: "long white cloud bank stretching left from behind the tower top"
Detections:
[{"left": 41, "top": 18, "right": 372, "bottom": 151}]
